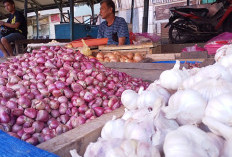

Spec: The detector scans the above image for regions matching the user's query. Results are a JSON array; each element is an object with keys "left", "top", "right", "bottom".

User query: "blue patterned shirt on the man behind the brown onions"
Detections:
[{"left": 97, "top": 16, "right": 130, "bottom": 45}]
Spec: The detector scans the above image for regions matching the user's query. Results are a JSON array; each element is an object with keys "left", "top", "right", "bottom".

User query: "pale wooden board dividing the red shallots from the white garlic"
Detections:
[{"left": 37, "top": 107, "right": 124, "bottom": 157}]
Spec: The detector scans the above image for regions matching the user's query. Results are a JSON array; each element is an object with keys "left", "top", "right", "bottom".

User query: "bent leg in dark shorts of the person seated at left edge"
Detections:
[{"left": 1, "top": 33, "right": 25, "bottom": 56}]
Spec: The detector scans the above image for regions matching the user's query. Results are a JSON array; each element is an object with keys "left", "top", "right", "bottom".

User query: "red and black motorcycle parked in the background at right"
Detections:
[{"left": 165, "top": 0, "right": 232, "bottom": 44}]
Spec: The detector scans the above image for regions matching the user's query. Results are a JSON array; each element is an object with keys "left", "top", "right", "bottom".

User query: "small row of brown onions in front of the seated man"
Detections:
[{"left": 96, "top": 51, "right": 144, "bottom": 63}]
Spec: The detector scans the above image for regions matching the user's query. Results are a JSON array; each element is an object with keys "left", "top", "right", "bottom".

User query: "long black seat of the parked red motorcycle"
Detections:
[{"left": 176, "top": 8, "right": 209, "bottom": 17}]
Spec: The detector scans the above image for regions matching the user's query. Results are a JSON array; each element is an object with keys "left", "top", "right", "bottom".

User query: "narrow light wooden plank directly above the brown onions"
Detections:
[{"left": 98, "top": 43, "right": 157, "bottom": 51}]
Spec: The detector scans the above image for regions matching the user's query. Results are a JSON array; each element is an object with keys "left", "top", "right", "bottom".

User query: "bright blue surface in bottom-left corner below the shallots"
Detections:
[{"left": 0, "top": 130, "right": 58, "bottom": 157}]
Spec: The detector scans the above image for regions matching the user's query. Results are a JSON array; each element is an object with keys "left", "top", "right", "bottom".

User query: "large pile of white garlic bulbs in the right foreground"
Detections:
[{"left": 75, "top": 45, "right": 232, "bottom": 157}]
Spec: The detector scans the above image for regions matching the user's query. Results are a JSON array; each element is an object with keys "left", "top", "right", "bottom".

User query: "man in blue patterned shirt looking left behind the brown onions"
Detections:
[{"left": 98, "top": 0, "right": 130, "bottom": 45}]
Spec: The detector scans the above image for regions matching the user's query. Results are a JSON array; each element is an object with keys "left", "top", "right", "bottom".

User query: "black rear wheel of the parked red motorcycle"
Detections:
[{"left": 168, "top": 20, "right": 191, "bottom": 44}]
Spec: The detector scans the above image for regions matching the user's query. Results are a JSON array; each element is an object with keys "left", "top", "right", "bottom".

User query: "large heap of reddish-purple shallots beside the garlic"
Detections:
[{"left": 0, "top": 46, "right": 148, "bottom": 145}]
